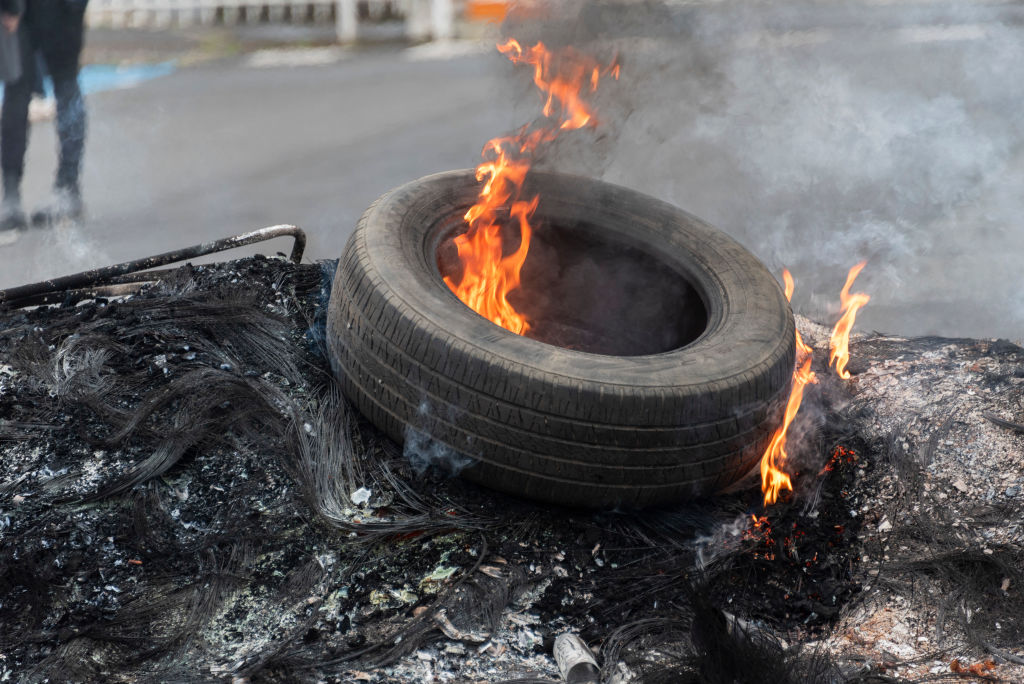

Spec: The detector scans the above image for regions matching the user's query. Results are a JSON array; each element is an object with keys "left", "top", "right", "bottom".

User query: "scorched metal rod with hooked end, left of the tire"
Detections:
[{"left": 0, "top": 225, "right": 306, "bottom": 305}]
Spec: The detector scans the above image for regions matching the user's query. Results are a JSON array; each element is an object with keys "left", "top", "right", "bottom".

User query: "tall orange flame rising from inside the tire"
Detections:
[{"left": 444, "top": 39, "right": 618, "bottom": 335}]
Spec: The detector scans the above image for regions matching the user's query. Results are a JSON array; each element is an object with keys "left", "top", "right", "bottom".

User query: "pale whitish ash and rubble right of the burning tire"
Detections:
[{"left": 798, "top": 317, "right": 1024, "bottom": 681}]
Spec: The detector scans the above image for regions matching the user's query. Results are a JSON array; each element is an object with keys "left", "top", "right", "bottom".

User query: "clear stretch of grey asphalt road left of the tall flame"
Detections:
[{"left": 0, "top": 43, "right": 510, "bottom": 286}]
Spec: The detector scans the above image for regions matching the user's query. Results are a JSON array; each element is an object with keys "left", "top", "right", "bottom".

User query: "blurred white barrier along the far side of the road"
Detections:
[{"left": 86, "top": 0, "right": 457, "bottom": 43}]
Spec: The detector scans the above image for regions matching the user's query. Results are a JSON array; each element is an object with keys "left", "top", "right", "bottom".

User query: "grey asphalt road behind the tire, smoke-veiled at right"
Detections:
[{"left": 0, "top": 0, "right": 1024, "bottom": 339}]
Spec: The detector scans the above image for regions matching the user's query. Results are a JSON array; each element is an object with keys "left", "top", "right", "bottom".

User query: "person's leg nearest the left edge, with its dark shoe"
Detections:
[{"left": 0, "top": 28, "right": 36, "bottom": 228}]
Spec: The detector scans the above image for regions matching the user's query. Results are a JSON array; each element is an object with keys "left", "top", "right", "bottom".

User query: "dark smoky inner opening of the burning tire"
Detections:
[{"left": 437, "top": 217, "right": 708, "bottom": 356}]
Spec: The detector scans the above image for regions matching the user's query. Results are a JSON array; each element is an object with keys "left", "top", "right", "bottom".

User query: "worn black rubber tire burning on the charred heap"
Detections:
[{"left": 328, "top": 171, "right": 795, "bottom": 507}]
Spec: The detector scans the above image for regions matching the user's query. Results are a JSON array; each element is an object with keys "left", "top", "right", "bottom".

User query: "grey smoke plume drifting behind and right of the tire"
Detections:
[{"left": 503, "top": 1, "right": 1024, "bottom": 340}]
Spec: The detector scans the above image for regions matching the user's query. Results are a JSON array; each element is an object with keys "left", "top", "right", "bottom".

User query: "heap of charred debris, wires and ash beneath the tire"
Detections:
[{"left": 0, "top": 257, "right": 1024, "bottom": 683}]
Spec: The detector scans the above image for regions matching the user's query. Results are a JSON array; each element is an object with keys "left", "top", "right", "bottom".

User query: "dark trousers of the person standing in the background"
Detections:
[{"left": 0, "top": 0, "right": 85, "bottom": 191}]
